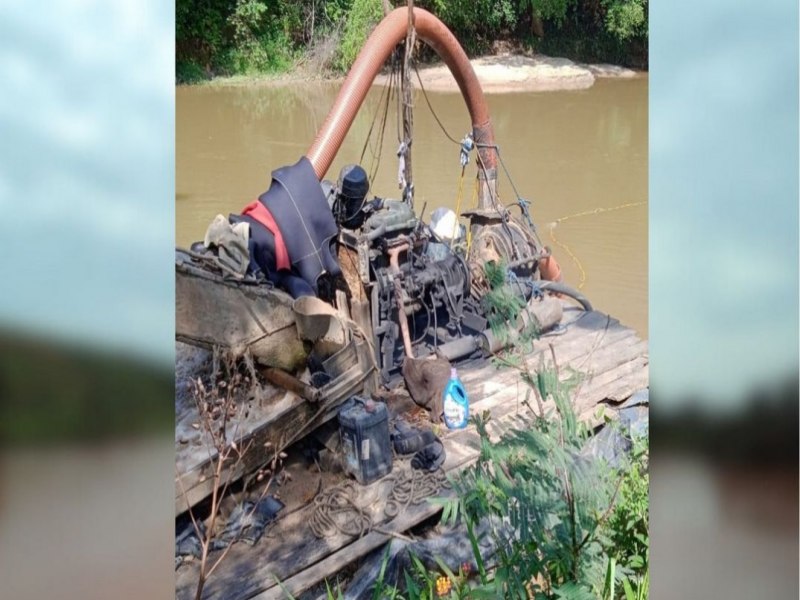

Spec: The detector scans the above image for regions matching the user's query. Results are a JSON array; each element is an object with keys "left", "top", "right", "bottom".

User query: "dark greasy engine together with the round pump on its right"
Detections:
[{"left": 323, "top": 165, "right": 542, "bottom": 384}]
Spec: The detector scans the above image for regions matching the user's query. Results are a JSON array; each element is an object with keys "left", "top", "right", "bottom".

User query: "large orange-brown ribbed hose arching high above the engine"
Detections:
[{"left": 306, "top": 7, "right": 497, "bottom": 185}]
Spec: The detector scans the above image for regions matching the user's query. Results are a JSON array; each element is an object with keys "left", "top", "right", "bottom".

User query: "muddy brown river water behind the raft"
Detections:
[{"left": 175, "top": 76, "right": 648, "bottom": 338}]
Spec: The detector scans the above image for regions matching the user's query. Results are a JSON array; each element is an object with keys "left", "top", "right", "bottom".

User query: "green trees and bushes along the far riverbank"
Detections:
[{"left": 175, "top": 0, "right": 648, "bottom": 83}]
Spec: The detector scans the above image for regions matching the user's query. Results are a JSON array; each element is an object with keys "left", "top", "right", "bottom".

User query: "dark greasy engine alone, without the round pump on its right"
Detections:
[{"left": 327, "top": 166, "right": 487, "bottom": 382}]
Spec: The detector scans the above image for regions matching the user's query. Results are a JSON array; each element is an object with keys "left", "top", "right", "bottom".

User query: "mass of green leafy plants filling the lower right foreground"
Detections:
[{"left": 304, "top": 358, "right": 649, "bottom": 600}]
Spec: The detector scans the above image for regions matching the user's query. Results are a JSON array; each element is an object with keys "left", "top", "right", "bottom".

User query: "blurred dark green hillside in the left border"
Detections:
[{"left": 0, "top": 330, "right": 175, "bottom": 447}]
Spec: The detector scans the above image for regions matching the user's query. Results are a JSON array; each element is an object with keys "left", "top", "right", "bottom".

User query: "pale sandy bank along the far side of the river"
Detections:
[{"left": 192, "top": 54, "right": 646, "bottom": 94}]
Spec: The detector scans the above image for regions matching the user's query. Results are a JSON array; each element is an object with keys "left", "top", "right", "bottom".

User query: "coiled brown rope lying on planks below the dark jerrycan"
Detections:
[{"left": 308, "top": 466, "right": 450, "bottom": 538}]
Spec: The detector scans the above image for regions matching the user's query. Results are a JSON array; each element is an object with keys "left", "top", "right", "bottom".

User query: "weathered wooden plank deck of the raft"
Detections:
[{"left": 176, "top": 305, "right": 648, "bottom": 600}]
